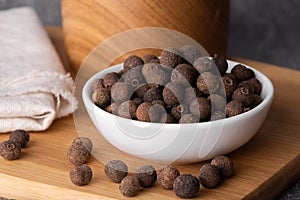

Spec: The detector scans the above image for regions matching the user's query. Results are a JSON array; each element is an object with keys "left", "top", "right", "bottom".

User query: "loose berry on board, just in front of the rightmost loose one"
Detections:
[{"left": 198, "top": 164, "right": 221, "bottom": 188}]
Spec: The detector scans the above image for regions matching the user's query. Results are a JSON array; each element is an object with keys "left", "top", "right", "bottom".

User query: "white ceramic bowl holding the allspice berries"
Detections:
[{"left": 82, "top": 60, "right": 274, "bottom": 163}]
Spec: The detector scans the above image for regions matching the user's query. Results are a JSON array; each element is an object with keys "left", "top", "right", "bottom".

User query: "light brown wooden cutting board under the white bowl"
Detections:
[{"left": 0, "top": 28, "right": 300, "bottom": 199}]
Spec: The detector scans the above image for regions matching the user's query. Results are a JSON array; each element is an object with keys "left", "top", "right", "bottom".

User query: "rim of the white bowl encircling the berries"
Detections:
[{"left": 82, "top": 59, "right": 274, "bottom": 127}]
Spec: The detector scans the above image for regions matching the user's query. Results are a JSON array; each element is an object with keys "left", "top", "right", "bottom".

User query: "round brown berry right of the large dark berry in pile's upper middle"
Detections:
[{"left": 197, "top": 72, "right": 219, "bottom": 94}]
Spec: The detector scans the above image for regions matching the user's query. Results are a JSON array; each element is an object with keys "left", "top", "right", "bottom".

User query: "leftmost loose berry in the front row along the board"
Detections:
[{"left": 70, "top": 164, "right": 93, "bottom": 186}]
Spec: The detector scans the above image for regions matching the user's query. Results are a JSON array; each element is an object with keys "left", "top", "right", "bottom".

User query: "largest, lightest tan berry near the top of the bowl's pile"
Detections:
[{"left": 142, "top": 63, "right": 170, "bottom": 85}]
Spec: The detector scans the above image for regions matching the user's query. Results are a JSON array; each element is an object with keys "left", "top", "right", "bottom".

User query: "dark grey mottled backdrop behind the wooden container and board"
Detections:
[{"left": 0, "top": 0, "right": 300, "bottom": 200}]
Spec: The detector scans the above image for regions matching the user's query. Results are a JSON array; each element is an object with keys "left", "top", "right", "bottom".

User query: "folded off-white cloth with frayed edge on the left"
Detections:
[{"left": 0, "top": 7, "right": 77, "bottom": 132}]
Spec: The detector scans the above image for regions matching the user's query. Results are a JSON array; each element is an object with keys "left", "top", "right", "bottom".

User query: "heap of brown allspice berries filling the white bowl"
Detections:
[{"left": 91, "top": 45, "right": 262, "bottom": 123}]
